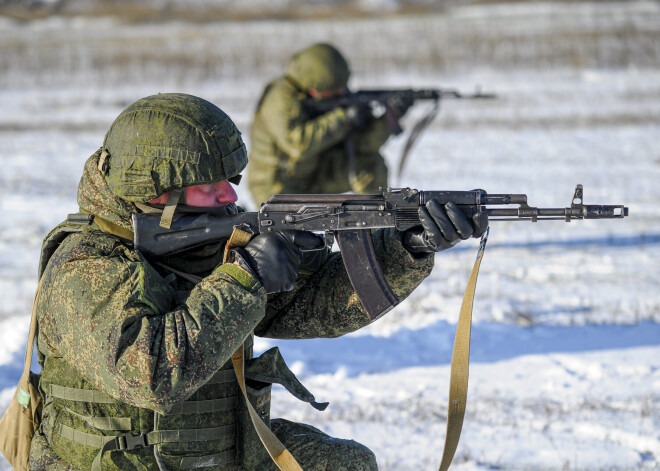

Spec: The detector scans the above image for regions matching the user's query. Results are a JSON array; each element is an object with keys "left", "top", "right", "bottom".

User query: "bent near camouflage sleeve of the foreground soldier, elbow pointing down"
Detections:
[{"left": 39, "top": 236, "right": 266, "bottom": 410}]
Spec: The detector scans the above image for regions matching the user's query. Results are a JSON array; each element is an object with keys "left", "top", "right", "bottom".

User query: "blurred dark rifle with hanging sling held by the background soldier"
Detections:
[{"left": 303, "top": 88, "right": 496, "bottom": 180}]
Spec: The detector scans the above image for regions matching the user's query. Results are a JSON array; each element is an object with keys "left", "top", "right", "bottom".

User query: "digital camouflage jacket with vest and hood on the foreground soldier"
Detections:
[{"left": 30, "top": 152, "right": 433, "bottom": 471}]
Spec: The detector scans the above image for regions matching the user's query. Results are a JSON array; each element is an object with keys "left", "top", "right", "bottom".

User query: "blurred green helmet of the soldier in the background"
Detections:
[{"left": 286, "top": 43, "right": 351, "bottom": 92}]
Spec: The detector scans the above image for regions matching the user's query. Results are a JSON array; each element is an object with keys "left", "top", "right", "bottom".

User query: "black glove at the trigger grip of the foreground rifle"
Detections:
[{"left": 233, "top": 230, "right": 325, "bottom": 294}]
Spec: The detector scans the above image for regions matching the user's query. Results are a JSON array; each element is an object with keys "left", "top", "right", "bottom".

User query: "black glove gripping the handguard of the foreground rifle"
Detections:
[{"left": 400, "top": 200, "right": 488, "bottom": 253}]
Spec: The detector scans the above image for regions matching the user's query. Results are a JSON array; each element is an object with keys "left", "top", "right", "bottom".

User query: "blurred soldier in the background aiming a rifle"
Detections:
[{"left": 248, "top": 44, "right": 412, "bottom": 205}]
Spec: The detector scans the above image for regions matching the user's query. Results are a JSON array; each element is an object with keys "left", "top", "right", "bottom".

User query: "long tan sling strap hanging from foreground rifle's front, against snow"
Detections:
[{"left": 439, "top": 229, "right": 488, "bottom": 471}]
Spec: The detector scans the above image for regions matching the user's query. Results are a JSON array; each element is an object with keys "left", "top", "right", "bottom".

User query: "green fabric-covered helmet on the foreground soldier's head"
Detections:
[{"left": 99, "top": 93, "right": 247, "bottom": 203}]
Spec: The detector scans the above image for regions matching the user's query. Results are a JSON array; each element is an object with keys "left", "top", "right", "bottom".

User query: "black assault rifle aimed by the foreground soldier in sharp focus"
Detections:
[{"left": 133, "top": 185, "right": 628, "bottom": 320}]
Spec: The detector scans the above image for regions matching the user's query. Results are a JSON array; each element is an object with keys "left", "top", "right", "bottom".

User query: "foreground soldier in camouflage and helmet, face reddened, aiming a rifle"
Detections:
[{"left": 30, "top": 94, "right": 487, "bottom": 471}]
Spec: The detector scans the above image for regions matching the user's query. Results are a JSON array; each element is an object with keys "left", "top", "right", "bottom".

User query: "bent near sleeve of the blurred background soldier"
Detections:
[{"left": 259, "top": 83, "right": 349, "bottom": 178}]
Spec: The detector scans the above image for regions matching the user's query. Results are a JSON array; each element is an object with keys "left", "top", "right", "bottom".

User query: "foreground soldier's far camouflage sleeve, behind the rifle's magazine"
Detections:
[{"left": 255, "top": 229, "right": 434, "bottom": 338}]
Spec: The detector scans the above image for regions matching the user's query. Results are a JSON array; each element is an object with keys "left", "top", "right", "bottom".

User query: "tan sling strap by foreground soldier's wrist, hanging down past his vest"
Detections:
[{"left": 224, "top": 227, "right": 302, "bottom": 471}]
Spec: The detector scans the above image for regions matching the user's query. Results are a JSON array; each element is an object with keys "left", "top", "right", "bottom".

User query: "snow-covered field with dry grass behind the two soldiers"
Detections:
[{"left": 0, "top": 2, "right": 660, "bottom": 471}]
